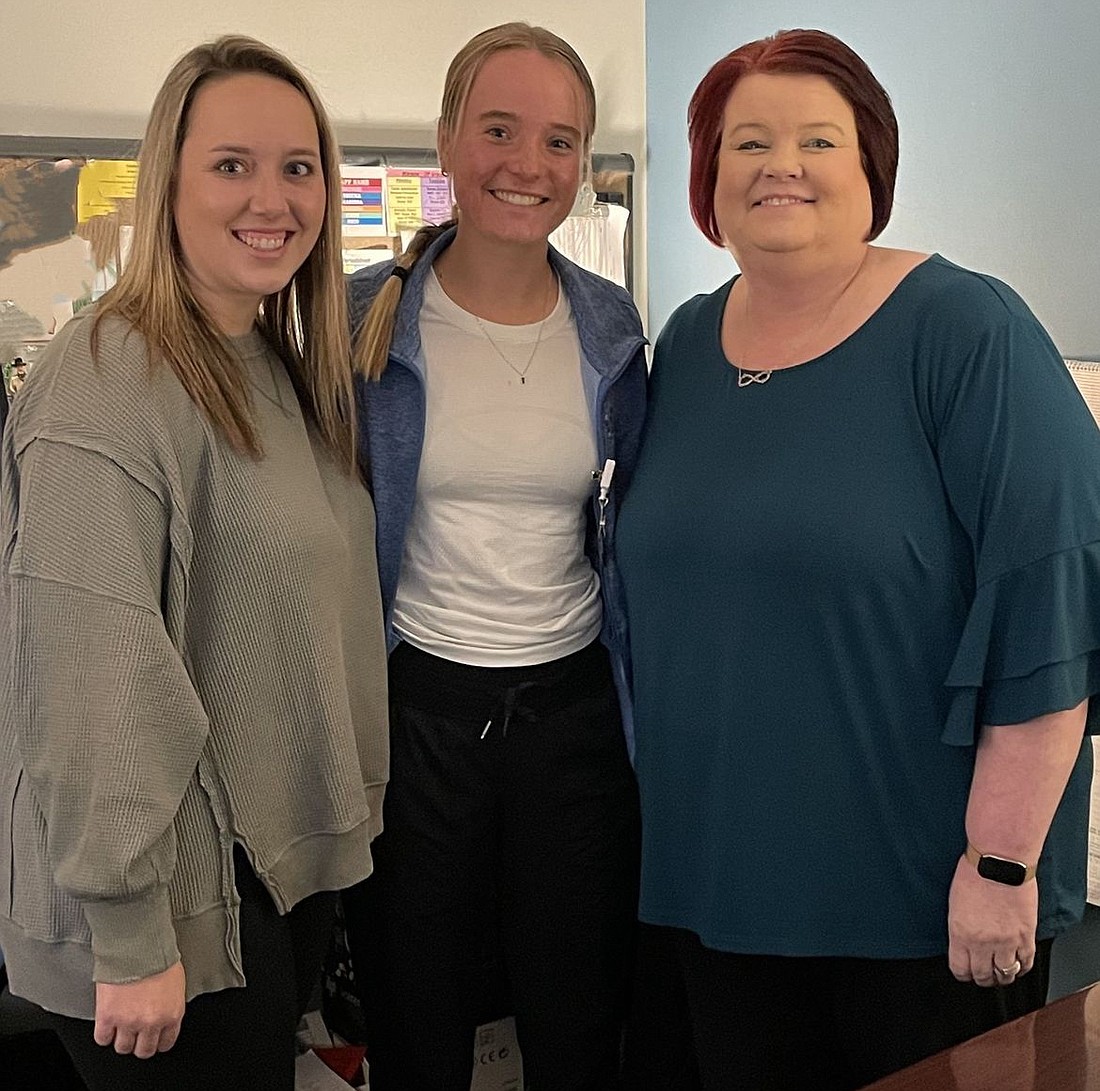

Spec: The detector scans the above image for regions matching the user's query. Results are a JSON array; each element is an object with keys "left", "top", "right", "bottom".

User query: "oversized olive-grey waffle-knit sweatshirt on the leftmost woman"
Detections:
[{"left": 0, "top": 313, "right": 388, "bottom": 1017}]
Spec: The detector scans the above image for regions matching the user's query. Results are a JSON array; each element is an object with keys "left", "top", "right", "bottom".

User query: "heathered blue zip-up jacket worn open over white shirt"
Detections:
[{"left": 348, "top": 228, "right": 647, "bottom": 759}]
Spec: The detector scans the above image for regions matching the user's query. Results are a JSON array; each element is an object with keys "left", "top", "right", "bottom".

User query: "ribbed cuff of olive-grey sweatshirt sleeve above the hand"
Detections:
[{"left": 84, "top": 886, "right": 179, "bottom": 984}]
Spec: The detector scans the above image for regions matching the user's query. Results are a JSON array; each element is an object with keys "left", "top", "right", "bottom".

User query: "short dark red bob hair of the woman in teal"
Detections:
[{"left": 688, "top": 30, "right": 898, "bottom": 246}]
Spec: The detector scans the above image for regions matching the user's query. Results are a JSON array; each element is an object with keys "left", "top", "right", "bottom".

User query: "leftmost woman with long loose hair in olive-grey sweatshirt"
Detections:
[{"left": 0, "top": 36, "right": 387, "bottom": 1091}]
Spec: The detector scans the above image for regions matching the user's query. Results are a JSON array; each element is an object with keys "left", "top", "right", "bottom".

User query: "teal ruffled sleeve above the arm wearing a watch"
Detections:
[{"left": 931, "top": 266, "right": 1100, "bottom": 746}]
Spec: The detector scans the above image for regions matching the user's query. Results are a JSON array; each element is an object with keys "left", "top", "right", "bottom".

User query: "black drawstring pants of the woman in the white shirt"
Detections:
[{"left": 344, "top": 643, "right": 639, "bottom": 1091}]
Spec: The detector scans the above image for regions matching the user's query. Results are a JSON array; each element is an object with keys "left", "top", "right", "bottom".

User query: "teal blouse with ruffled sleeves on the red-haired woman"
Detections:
[{"left": 617, "top": 256, "right": 1100, "bottom": 958}]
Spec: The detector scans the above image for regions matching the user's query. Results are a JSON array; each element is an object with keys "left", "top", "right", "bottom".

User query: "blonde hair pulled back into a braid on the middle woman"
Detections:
[{"left": 355, "top": 23, "right": 596, "bottom": 379}]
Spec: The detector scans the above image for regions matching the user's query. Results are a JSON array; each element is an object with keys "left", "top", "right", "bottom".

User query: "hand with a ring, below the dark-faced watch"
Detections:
[{"left": 947, "top": 857, "right": 1038, "bottom": 988}]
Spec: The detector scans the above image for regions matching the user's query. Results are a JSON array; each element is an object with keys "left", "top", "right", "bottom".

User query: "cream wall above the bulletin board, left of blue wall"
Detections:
[{"left": 0, "top": 0, "right": 646, "bottom": 313}]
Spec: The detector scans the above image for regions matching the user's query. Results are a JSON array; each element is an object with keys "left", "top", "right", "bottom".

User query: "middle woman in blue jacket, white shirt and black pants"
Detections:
[{"left": 345, "top": 23, "right": 646, "bottom": 1091}]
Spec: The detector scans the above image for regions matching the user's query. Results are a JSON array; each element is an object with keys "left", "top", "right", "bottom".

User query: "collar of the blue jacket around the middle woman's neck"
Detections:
[{"left": 380, "top": 228, "right": 646, "bottom": 378}]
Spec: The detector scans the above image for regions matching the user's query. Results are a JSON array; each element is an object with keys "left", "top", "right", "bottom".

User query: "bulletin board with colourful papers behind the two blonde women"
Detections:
[{"left": 0, "top": 135, "right": 634, "bottom": 373}]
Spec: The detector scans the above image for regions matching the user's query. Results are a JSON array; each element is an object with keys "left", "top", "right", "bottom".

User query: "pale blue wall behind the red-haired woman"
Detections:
[{"left": 646, "top": 0, "right": 1100, "bottom": 357}]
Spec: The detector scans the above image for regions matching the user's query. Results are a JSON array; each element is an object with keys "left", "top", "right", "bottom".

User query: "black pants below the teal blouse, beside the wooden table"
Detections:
[{"left": 626, "top": 925, "right": 1052, "bottom": 1091}]
